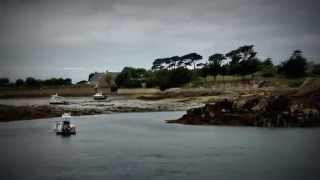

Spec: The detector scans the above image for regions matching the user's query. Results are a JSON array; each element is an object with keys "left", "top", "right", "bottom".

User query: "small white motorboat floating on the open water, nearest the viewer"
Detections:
[{"left": 54, "top": 113, "right": 76, "bottom": 136}]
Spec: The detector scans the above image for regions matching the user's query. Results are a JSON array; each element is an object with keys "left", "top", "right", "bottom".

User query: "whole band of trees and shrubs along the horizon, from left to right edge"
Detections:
[{"left": 0, "top": 45, "right": 320, "bottom": 92}]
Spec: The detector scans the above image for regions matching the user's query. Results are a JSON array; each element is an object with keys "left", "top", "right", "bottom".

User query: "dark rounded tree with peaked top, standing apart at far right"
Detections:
[{"left": 279, "top": 50, "right": 307, "bottom": 78}]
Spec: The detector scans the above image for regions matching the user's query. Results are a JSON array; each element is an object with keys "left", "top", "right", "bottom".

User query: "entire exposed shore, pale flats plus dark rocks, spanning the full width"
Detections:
[{"left": 0, "top": 78, "right": 320, "bottom": 127}]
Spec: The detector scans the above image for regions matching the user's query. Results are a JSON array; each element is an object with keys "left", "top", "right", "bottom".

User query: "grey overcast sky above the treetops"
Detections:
[{"left": 0, "top": 0, "right": 320, "bottom": 82}]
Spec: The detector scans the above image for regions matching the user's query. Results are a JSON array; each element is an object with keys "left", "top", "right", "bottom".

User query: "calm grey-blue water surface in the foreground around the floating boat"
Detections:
[{"left": 0, "top": 112, "right": 320, "bottom": 180}]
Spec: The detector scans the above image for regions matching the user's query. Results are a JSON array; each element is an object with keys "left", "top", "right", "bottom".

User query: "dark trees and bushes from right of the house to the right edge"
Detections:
[{"left": 115, "top": 45, "right": 320, "bottom": 90}]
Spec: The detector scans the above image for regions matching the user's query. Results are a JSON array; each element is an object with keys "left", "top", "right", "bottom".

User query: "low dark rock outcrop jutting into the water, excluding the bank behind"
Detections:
[{"left": 167, "top": 95, "right": 320, "bottom": 127}]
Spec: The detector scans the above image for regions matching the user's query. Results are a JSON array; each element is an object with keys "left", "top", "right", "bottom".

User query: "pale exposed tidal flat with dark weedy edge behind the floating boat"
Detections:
[{"left": 0, "top": 96, "right": 203, "bottom": 122}]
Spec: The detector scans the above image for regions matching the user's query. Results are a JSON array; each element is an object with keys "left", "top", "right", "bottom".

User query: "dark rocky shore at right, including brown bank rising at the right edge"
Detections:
[{"left": 167, "top": 79, "right": 320, "bottom": 127}]
